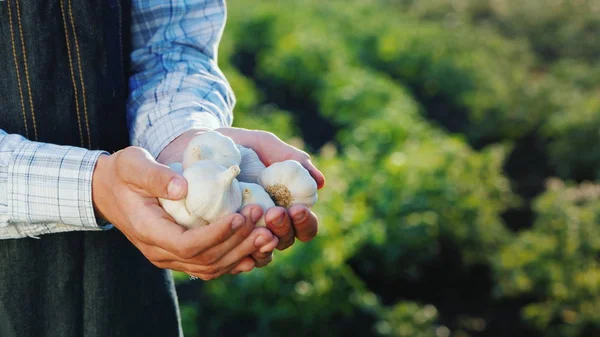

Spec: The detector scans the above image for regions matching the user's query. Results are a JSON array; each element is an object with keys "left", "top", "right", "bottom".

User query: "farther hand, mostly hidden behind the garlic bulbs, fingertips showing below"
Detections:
[{"left": 216, "top": 128, "right": 325, "bottom": 249}]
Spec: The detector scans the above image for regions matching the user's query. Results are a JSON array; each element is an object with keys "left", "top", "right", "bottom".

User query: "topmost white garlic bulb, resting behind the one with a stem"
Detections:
[{"left": 182, "top": 131, "right": 242, "bottom": 170}]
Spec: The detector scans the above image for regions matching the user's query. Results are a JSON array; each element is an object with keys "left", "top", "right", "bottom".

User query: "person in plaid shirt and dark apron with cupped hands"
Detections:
[{"left": 0, "top": 0, "right": 324, "bottom": 337}]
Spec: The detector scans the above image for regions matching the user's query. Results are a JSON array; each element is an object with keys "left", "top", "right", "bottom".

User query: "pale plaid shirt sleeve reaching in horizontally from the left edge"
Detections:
[{"left": 0, "top": 130, "right": 111, "bottom": 239}]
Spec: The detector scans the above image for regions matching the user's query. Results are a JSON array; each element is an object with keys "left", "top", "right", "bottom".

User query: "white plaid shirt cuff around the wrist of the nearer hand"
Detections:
[{"left": 7, "top": 142, "right": 111, "bottom": 229}]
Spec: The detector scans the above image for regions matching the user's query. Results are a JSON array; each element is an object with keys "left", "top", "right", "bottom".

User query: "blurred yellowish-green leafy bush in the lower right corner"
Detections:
[{"left": 494, "top": 180, "right": 600, "bottom": 336}]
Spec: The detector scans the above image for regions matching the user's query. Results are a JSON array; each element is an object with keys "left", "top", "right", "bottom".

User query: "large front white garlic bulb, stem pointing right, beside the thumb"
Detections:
[{"left": 183, "top": 160, "right": 242, "bottom": 223}]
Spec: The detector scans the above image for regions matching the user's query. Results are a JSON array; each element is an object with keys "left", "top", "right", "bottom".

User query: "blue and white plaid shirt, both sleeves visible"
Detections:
[{"left": 0, "top": 0, "right": 235, "bottom": 239}]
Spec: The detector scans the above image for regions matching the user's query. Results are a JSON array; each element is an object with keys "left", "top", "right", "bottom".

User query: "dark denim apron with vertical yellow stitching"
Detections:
[{"left": 0, "top": 0, "right": 181, "bottom": 337}]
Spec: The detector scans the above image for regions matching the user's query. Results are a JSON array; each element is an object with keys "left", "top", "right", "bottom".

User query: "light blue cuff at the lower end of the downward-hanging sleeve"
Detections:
[{"left": 133, "top": 109, "right": 226, "bottom": 158}]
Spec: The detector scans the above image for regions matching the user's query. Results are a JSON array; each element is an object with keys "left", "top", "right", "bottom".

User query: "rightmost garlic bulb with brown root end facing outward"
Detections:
[{"left": 258, "top": 160, "right": 317, "bottom": 208}]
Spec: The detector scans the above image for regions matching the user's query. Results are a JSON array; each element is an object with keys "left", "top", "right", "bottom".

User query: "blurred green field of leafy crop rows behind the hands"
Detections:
[{"left": 175, "top": 0, "right": 600, "bottom": 337}]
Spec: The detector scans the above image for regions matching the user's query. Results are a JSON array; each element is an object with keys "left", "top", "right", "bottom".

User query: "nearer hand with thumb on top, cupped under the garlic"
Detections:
[{"left": 92, "top": 147, "right": 278, "bottom": 280}]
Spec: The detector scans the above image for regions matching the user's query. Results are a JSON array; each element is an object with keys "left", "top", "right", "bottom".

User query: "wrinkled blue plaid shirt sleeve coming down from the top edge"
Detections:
[{"left": 127, "top": 0, "right": 235, "bottom": 157}]
